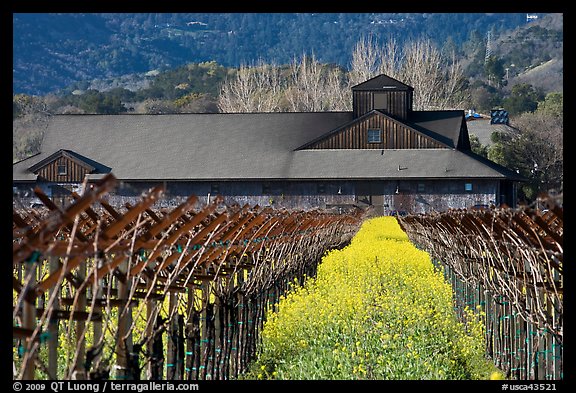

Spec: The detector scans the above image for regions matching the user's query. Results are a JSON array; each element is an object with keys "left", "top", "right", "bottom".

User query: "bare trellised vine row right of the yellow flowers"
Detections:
[{"left": 399, "top": 195, "right": 563, "bottom": 380}]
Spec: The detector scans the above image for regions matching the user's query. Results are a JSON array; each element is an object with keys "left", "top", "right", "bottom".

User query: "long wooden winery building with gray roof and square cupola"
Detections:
[{"left": 13, "top": 75, "right": 522, "bottom": 214}]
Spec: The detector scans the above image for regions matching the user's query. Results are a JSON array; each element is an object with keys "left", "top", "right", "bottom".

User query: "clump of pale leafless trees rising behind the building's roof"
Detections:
[{"left": 218, "top": 36, "right": 463, "bottom": 112}]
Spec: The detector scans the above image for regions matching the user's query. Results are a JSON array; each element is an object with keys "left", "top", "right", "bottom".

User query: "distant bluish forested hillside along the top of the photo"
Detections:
[{"left": 13, "top": 13, "right": 532, "bottom": 94}]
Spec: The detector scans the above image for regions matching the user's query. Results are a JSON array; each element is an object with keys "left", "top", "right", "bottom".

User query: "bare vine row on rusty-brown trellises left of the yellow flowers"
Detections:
[{"left": 13, "top": 174, "right": 362, "bottom": 380}]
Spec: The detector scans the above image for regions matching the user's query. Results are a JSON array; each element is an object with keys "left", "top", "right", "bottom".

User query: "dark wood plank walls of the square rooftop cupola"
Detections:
[{"left": 353, "top": 90, "right": 412, "bottom": 120}]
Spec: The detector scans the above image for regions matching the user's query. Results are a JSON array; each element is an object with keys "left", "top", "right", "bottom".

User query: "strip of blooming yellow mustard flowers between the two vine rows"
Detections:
[{"left": 244, "top": 217, "right": 498, "bottom": 379}]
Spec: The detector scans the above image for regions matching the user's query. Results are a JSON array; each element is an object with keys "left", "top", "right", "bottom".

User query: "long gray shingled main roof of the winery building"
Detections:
[{"left": 13, "top": 112, "right": 520, "bottom": 181}]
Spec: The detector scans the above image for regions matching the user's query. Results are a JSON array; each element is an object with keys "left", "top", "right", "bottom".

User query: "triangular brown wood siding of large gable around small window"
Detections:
[{"left": 307, "top": 113, "right": 446, "bottom": 149}]
